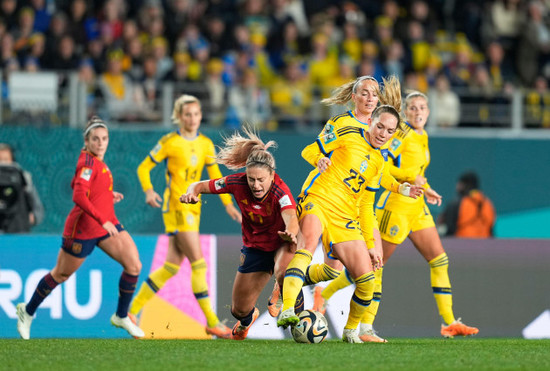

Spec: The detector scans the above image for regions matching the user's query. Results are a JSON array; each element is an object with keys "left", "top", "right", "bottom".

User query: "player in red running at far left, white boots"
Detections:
[{"left": 17, "top": 117, "right": 144, "bottom": 339}]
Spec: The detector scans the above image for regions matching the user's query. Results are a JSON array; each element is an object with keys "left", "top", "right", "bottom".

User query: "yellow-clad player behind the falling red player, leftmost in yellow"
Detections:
[{"left": 130, "top": 95, "right": 241, "bottom": 338}]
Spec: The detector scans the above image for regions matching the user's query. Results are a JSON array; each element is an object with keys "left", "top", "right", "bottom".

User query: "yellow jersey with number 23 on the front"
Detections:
[{"left": 302, "top": 126, "right": 388, "bottom": 219}]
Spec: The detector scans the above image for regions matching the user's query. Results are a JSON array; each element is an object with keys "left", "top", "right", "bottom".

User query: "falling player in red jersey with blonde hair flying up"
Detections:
[{"left": 180, "top": 129, "right": 300, "bottom": 340}]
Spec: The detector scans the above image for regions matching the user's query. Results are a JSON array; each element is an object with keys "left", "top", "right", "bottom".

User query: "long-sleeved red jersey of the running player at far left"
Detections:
[{"left": 63, "top": 151, "right": 119, "bottom": 240}]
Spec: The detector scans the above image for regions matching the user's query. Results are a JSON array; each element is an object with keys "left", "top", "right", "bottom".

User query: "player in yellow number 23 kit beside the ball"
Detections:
[{"left": 277, "top": 105, "right": 424, "bottom": 343}]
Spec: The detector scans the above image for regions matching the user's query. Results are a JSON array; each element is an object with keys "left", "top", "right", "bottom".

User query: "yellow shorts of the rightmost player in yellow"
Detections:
[{"left": 376, "top": 206, "right": 435, "bottom": 245}]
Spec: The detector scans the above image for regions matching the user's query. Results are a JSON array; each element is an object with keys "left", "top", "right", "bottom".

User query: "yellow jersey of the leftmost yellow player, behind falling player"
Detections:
[{"left": 138, "top": 130, "right": 232, "bottom": 212}]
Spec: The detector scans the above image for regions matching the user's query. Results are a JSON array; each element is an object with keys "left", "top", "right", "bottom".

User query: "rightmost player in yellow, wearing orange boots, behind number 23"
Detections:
[{"left": 378, "top": 92, "right": 479, "bottom": 337}]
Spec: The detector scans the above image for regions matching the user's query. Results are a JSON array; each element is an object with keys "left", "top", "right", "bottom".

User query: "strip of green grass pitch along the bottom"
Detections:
[{"left": 0, "top": 338, "right": 550, "bottom": 371}]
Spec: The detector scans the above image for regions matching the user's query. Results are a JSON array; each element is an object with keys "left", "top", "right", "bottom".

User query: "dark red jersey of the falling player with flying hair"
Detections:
[{"left": 208, "top": 173, "right": 296, "bottom": 251}]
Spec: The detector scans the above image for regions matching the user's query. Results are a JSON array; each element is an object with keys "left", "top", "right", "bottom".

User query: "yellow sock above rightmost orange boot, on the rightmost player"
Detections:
[{"left": 429, "top": 253, "right": 455, "bottom": 324}]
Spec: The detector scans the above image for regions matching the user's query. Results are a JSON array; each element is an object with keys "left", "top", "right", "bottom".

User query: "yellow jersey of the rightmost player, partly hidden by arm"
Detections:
[{"left": 376, "top": 123, "right": 430, "bottom": 214}]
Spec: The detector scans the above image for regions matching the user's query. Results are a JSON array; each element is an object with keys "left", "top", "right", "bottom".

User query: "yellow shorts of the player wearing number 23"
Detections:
[{"left": 296, "top": 194, "right": 363, "bottom": 259}]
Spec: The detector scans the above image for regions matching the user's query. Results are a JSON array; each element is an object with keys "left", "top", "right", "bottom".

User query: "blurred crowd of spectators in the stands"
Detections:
[{"left": 0, "top": 0, "right": 550, "bottom": 128}]
